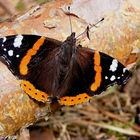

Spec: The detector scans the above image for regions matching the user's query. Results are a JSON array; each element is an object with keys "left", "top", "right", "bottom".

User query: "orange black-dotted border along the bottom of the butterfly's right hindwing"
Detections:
[{"left": 59, "top": 93, "right": 91, "bottom": 106}]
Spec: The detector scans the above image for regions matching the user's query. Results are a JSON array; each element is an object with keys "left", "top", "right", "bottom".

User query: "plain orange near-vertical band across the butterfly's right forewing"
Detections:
[{"left": 90, "top": 51, "right": 102, "bottom": 91}]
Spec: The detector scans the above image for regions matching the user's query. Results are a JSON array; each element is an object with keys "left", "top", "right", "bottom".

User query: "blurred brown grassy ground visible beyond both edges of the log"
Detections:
[{"left": 0, "top": 0, "right": 140, "bottom": 140}]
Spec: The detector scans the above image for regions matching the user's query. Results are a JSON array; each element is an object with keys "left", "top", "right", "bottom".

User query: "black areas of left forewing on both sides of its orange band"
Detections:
[{"left": 0, "top": 35, "right": 61, "bottom": 77}]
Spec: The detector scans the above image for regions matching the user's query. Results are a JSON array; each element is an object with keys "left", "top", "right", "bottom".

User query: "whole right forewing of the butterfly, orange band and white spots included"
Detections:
[{"left": 74, "top": 48, "right": 131, "bottom": 96}]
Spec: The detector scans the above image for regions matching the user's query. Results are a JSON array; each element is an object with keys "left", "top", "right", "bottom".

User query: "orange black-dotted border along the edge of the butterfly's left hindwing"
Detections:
[{"left": 21, "top": 80, "right": 48, "bottom": 102}]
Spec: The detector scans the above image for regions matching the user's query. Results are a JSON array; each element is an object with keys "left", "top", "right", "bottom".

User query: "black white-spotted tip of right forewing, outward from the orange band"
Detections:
[{"left": 95, "top": 52, "right": 131, "bottom": 94}]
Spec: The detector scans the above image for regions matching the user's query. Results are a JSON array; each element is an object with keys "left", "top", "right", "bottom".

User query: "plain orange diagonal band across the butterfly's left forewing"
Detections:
[{"left": 19, "top": 37, "right": 45, "bottom": 75}]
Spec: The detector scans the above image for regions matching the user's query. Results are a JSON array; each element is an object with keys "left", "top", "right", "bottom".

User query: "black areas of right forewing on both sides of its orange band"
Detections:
[{"left": 77, "top": 48, "right": 131, "bottom": 95}]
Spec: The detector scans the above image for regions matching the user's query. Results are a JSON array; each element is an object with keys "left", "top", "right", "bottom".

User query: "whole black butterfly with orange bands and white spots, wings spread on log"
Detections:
[{"left": 0, "top": 32, "right": 131, "bottom": 106}]
